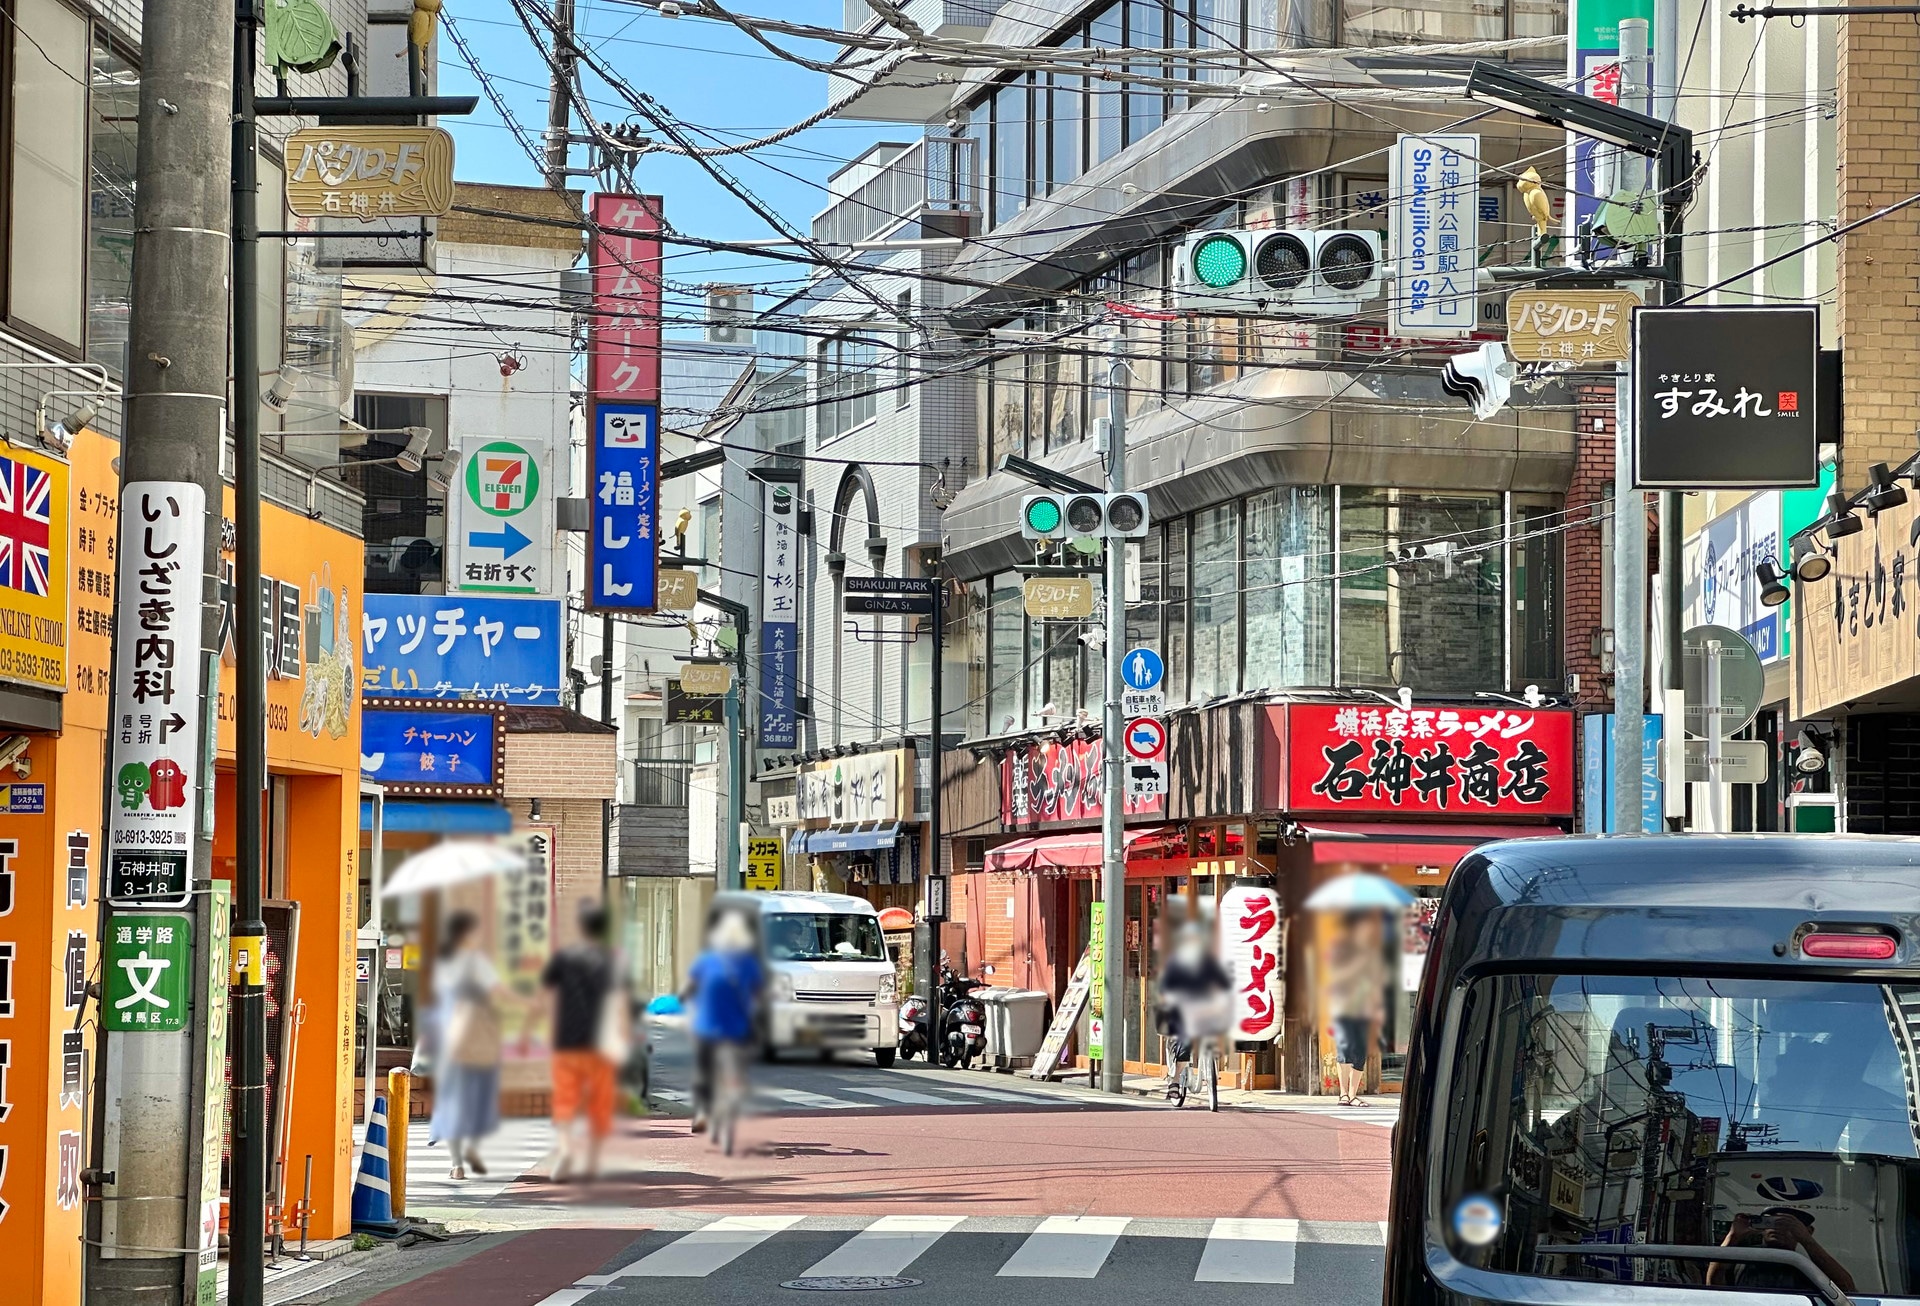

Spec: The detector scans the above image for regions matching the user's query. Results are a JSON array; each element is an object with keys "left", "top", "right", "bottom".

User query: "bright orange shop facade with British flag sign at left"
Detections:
[{"left": 0, "top": 430, "right": 361, "bottom": 1306}]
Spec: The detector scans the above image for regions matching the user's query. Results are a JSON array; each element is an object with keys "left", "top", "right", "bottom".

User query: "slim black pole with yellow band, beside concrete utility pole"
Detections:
[{"left": 228, "top": 0, "right": 270, "bottom": 1306}]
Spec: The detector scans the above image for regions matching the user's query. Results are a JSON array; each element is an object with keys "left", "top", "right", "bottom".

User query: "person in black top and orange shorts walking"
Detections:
[{"left": 540, "top": 903, "right": 622, "bottom": 1183}]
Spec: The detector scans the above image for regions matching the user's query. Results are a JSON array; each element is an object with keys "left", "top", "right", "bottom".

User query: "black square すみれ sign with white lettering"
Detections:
[{"left": 1632, "top": 305, "right": 1812, "bottom": 490}]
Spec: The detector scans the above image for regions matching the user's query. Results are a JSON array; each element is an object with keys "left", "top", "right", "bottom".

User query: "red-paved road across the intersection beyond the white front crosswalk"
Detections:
[{"left": 505, "top": 1108, "right": 1388, "bottom": 1220}]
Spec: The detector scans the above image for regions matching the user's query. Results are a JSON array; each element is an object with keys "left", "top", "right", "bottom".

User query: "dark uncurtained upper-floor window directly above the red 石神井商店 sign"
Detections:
[{"left": 1340, "top": 490, "right": 1505, "bottom": 693}]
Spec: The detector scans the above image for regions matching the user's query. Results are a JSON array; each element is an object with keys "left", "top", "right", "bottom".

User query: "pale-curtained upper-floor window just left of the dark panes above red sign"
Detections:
[{"left": 1242, "top": 486, "right": 1332, "bottom": 689}]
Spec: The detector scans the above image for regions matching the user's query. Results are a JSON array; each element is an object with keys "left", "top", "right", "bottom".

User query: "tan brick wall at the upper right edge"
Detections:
[{"left": 1837, "top": 17, "right": 1920, "bottom": 490}]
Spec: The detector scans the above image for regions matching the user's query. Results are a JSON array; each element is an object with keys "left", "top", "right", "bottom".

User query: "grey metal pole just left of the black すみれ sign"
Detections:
[{"left": 1613, "top": 19, "right": 1651, "bottom": 834}]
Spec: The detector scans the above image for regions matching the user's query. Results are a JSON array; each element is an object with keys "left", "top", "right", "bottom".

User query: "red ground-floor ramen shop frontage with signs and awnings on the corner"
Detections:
[{"left": 945, "top": 699, "right": 1574, "bottom": 1093}]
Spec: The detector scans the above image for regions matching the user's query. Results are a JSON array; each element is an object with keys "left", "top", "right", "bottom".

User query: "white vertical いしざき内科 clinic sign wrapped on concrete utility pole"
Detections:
[{"left": 108, "top": 480, "right": 207, "bottom": 907}]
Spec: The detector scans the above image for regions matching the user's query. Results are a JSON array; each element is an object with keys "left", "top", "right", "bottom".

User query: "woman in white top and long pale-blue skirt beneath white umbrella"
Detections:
[{"left": 430, "top": 912, "right": 501, "bottom": 1179}]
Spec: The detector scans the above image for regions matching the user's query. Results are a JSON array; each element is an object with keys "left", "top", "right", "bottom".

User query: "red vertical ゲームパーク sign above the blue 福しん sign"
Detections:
[{"left": 588, "top": 194, "right": 660, "bottom": 403}]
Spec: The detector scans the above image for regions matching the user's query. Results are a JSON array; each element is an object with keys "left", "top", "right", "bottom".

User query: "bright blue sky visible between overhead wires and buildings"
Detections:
[{"left": 440, "top": 0, "right": 902, "bottom": 305}]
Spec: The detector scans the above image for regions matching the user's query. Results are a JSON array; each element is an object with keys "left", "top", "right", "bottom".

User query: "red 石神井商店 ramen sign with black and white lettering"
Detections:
[{"left": 1286, "top": 703, "right": 1574, "bottom": 816}]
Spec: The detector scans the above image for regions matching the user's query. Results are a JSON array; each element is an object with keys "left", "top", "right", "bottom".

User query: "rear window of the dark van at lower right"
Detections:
[{"left": 1436, "top": 976, "right": 1920, "bottom": 1296}]
